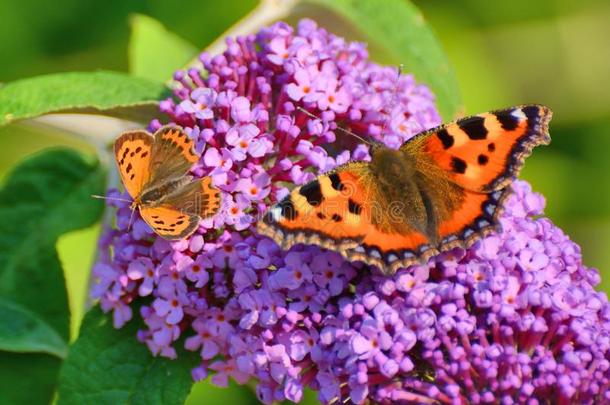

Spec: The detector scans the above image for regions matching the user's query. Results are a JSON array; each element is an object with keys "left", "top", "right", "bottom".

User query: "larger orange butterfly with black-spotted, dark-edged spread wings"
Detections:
[{"left": 258, "top": 105, "right": 551, "bottom": 273}]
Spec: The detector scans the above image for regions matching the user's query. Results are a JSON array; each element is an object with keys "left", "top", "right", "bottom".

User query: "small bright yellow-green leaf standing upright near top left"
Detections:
[{"left": 128, "top": 14, "right": 197, "bottom": 83}]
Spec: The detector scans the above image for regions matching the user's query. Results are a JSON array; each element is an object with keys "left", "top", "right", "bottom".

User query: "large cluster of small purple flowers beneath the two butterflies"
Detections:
[{"left": 91, "top": 20, "right": 610, "bottom": 404}]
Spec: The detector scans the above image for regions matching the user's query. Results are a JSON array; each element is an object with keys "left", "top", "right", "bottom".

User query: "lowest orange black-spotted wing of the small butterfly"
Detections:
[{"left": 140, "top": 205, "right": 199, "bottom": 240}]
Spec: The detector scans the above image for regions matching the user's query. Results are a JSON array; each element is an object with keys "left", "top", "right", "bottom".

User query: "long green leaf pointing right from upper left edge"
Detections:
[{"left": 0, "top": 71, "right": 168, "bottom": 125}]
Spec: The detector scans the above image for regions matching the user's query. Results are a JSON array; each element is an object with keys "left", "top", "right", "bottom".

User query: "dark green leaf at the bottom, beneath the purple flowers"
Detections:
[{"left": 58, "top": 307, "right": 199, "bottom": 405}]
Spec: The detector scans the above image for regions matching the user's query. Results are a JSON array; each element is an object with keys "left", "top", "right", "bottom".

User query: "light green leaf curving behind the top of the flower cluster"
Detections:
[{"left": 291, "top": 0, "right": 463, "bottom": 120}]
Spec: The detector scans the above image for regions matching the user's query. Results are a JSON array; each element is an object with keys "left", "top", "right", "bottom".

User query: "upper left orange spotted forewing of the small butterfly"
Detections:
[{"left": 114, "top": 131, "right": 153, "bottom": 198}]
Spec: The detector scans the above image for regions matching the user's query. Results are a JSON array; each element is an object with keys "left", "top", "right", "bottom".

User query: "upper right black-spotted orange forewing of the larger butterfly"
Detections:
[{"left": 401, "top": 105, "right": 552, "bottom": 192}]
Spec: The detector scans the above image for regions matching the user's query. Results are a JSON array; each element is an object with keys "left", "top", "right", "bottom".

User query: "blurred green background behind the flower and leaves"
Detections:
[{"left": 0, "top": 0, "right": 610, "bottom": 404}]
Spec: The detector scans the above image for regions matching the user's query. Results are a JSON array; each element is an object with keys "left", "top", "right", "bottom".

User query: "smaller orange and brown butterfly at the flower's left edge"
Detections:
[{"left": 114, "top": 126, "right": 220, "bottom": 240}]
